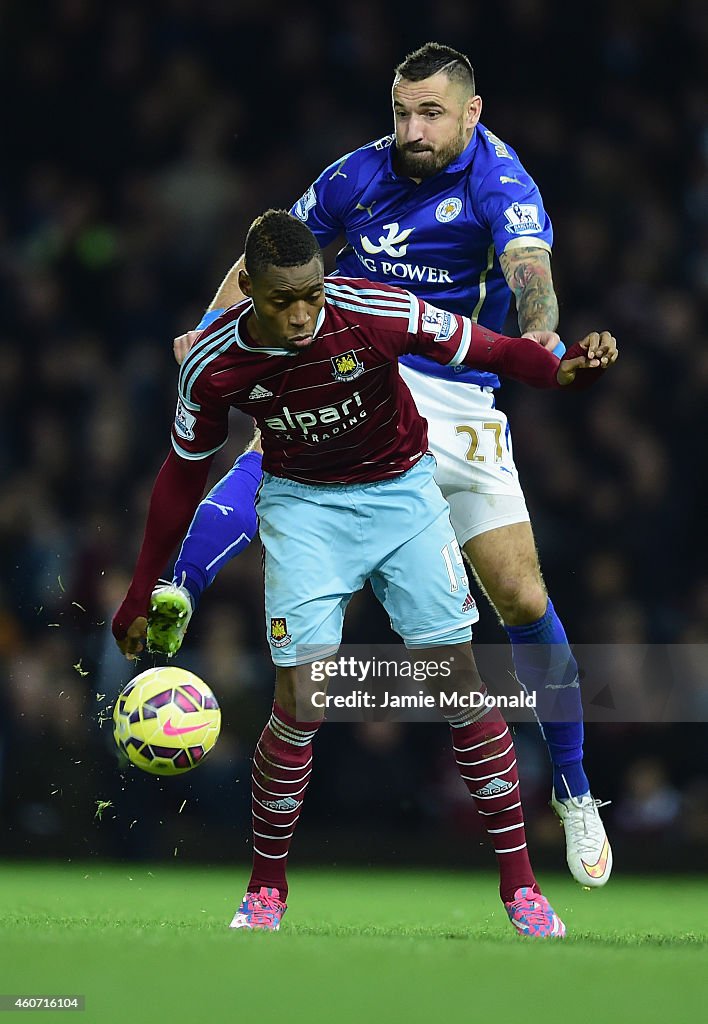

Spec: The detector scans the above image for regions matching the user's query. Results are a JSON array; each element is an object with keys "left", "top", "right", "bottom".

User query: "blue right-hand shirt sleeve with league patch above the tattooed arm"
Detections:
[{"left": 477, "top": 164, "right": 553, "bottom": 255}]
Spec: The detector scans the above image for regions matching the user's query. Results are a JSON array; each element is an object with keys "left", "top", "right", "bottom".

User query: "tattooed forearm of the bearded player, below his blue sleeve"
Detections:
[{"left": 499, "top": 246, "right": 558, "bottom": 334}]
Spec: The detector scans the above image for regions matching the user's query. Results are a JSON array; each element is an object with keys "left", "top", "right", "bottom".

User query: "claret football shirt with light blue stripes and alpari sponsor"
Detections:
[{"left": 172, "top": 276, "right": 557, "bottom": 483}]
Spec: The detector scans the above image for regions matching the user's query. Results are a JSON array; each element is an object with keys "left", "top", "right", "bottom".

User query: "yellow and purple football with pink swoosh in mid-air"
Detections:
[{"left": 113, "top": 666, "right": 221, "bottom": 775}]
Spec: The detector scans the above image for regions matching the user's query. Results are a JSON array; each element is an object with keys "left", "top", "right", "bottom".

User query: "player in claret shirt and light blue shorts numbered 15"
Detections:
[{"left": 113, "top": 211, "right": 617, "bottom": 937}]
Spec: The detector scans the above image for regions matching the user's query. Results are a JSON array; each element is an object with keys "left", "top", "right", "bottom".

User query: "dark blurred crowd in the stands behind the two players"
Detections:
[{"left": 0, "top": 0, "right": 708, "bottom": 869}]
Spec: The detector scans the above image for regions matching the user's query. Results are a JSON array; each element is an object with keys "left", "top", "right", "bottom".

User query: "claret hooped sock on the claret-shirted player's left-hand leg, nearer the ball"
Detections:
[{"left": 248, "top": 703, "right": 322, "bottom": 901}]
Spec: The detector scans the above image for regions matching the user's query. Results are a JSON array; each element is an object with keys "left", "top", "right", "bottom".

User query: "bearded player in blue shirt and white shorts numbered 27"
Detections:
[{"left": 148, "top": 43, "right": 612, "bottom": 886}]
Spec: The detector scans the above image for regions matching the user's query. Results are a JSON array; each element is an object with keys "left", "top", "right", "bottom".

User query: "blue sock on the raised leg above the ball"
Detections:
[{"left": 174, "top": 452, "right": 263, "bottom": 608}]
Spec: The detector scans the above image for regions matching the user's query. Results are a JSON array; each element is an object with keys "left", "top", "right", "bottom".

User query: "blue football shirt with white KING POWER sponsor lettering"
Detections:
[{"left": 291, "top": 124, "right": 553, "bottom": 387}]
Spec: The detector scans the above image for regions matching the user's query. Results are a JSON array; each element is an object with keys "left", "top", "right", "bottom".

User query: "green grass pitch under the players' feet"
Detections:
[{"left": 0, "top": 864, "right": 708, "bottom": 1024}]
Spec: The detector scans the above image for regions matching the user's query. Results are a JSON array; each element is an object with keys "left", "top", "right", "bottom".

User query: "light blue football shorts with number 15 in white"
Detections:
[{"left": 256, "top": 455, "right": 478, "bottom": 666}]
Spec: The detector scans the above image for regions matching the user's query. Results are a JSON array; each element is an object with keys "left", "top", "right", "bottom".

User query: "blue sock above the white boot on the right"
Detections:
[{"left": 505, "top": 598, "right": 590, "bottom": 800}]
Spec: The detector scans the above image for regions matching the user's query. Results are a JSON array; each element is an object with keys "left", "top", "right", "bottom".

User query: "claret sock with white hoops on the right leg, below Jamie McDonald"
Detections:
[{"left": 446, "top": 708, "right": 540, "bottom": 902}]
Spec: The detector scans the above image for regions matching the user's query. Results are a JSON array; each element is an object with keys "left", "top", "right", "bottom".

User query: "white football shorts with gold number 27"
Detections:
[{"left": 399, "top": 364, "right": 529, "bottom": 547}]
